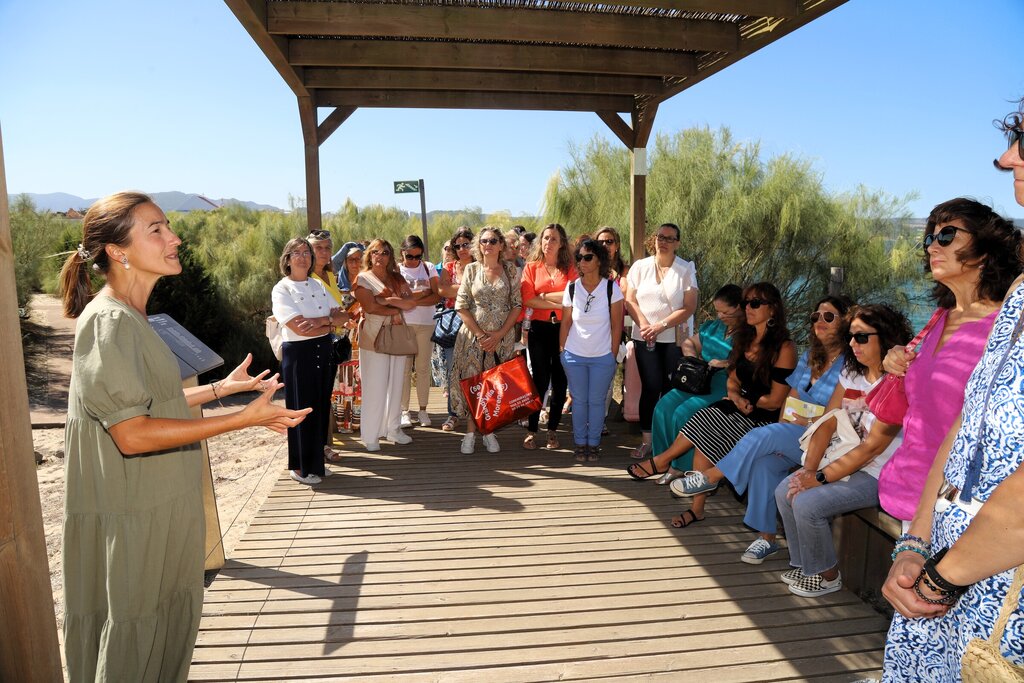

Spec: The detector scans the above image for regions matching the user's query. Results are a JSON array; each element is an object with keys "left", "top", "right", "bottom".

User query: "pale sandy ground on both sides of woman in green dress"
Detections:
[{"left": 29, "top": 297, "right": 288, "bottom": 627}]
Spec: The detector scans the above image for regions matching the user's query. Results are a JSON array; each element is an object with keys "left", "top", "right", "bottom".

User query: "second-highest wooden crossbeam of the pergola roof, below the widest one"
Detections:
[{"left": 289, "top": 38, "right": 697, "bottom": 77}]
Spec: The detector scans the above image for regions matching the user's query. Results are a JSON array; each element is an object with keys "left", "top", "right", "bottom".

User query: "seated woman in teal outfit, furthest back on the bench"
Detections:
[{"left": 651, "top": 285, "right": 743, "bottom": 483}]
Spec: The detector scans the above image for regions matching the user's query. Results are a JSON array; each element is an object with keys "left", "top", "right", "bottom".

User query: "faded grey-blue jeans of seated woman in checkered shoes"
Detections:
[{"left": 775, "top": 472, "right": 879, "bottom": 575}]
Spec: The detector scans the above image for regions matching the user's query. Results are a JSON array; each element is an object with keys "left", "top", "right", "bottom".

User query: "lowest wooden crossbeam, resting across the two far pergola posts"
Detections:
[{"left": 316, "top": 90, "right": 633, "bottom": 112}]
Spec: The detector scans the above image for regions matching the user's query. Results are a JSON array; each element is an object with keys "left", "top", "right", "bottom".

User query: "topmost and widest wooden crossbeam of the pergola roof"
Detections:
[{"left": 267, "top": 2, "right": 739, "bottom": 52}]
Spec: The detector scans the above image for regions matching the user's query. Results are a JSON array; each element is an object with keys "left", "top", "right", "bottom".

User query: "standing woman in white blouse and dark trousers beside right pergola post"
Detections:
[{"left": 626, "top": 223, "right": 700, "bottom": 459}]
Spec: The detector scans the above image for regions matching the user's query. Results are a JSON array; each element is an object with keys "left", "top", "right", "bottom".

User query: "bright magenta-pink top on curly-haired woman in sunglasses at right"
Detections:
[{"left": 879, "top": 311, "right": 998, "bottom": 519}]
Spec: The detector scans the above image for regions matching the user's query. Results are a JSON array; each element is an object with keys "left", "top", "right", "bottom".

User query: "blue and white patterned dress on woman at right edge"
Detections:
[{"left": 883, "top": 285, "right": 1024, "bottom": 683}]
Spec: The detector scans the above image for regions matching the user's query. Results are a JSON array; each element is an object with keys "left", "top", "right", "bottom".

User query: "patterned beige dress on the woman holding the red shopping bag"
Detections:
[{"left": 449, "top": 262, "right": 522, "bottom": 418}]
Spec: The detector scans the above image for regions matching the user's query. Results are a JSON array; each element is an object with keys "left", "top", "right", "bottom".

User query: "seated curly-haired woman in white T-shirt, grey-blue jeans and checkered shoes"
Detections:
[{"left": 775, "top": 304, "right": 910, "bottom": 598}]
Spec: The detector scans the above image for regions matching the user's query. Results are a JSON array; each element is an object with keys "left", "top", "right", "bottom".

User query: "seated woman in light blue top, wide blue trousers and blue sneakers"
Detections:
[{"left": 672, "top": 296, "right": 853, "bottom": 564}]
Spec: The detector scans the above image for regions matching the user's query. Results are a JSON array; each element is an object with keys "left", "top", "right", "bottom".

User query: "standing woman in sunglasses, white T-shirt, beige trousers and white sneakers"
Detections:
[{"left": 398, "top": 234, "right": 441, "bottom": 427}]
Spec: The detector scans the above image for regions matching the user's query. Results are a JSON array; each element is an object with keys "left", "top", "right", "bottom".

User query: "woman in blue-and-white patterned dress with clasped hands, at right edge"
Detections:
[{"left": 883, "top": 100, "right": 1024, "bottom": 683}]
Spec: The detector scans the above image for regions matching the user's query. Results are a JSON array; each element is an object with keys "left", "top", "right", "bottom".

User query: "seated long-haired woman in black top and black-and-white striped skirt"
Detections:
[{"left": 627, "top": 283, "right": 797, "bottom": 527}]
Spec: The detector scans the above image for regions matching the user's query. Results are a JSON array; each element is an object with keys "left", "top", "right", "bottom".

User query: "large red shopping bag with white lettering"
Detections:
[{"left": 459, "top": 354, "right": 542, "bottom": 434}]
